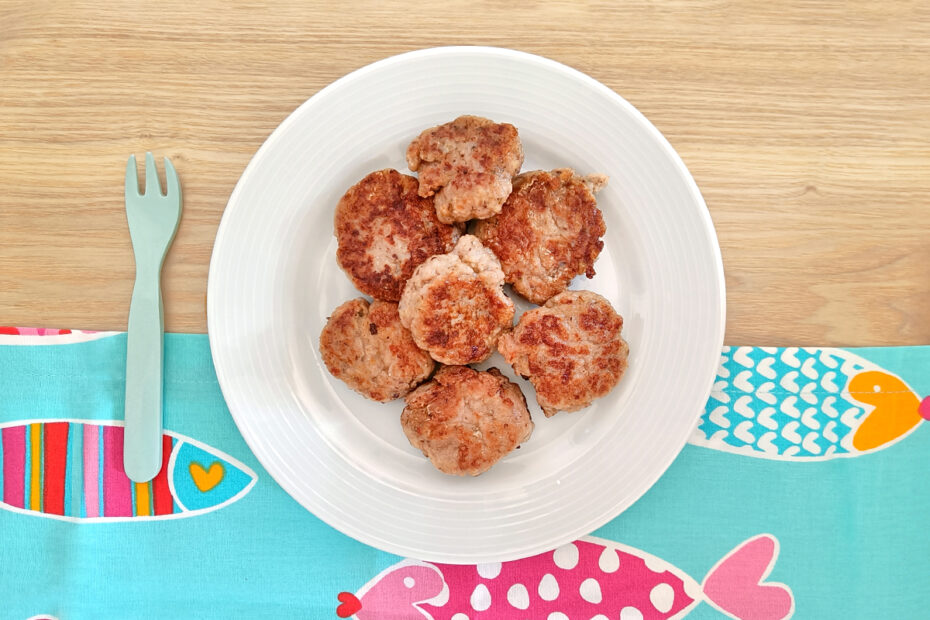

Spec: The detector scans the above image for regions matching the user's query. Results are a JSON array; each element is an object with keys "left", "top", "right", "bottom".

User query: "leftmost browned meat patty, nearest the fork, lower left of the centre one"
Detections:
[{"left": 320, "top": 297, "right": 435, "bottom": 402}]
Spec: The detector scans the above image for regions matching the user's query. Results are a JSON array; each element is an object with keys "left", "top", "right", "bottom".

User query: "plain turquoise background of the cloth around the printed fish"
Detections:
[{"left": 0, "top": 334, "right": 930, "bottom": 620}]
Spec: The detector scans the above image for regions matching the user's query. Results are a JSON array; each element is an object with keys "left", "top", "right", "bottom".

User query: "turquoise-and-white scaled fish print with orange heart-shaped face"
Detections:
[{"left": 689, "top": 347, "right": 930, "bottom": 461}]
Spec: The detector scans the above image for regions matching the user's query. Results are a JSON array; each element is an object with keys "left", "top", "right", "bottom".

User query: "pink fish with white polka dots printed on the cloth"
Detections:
[{"left": 336, "top": 534, "right": 794, "bottom": 620}]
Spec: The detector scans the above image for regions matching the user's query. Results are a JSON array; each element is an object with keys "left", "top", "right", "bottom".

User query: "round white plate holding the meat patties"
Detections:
[{"left": 207, "top": 47, "right": 724, "bottom": 563}]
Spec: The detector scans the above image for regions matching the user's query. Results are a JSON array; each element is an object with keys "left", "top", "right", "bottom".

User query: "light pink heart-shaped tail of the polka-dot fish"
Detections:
[{"left": 702, "top": 534, "right": 794, "bottom": 620}]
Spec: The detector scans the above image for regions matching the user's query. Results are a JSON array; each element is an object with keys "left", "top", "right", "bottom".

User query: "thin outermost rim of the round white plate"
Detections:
[{"left": 206, "top": 45, "right": 726, "bottom": 564}]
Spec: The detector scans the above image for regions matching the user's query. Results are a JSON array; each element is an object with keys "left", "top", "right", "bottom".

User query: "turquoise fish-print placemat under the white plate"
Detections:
[{"left": 0, "top": 328, "right": 930, "bottom": 620}]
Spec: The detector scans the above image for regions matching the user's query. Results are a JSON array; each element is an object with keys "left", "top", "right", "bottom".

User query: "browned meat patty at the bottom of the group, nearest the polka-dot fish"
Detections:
[{"left": 401, "top": 366, "right": 533, "bottom": 476}]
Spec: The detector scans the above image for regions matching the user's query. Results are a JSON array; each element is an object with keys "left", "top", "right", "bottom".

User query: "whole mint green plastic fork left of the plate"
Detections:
[{"left": 123, "top": 153, "right": 181, "bottom": 482}]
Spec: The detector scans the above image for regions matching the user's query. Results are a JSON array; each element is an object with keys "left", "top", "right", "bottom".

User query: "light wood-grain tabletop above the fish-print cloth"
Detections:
[{"left": 0, "top": 0, "right": 930, "bottom": 345}]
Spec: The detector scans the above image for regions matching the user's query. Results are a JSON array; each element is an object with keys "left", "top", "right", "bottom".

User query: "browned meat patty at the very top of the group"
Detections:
[{"left": 407, "top": 116, "right": 523, "bottom": 223}]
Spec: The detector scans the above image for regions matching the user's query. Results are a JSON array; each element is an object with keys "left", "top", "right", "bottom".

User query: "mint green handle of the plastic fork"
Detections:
[{"left": 123, "top": 269, "right": 164, "bottom": 482}]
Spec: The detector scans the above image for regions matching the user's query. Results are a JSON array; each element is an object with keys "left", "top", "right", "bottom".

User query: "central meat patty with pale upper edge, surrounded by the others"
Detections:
[{"left": 400, "top": 235, "right": 514, "bottom": 364}]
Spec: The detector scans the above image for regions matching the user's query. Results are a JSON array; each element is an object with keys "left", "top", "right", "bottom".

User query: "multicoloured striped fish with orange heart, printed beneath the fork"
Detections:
[{"left": 0, "top": 420, "right": 257, "bottom": 522}]
